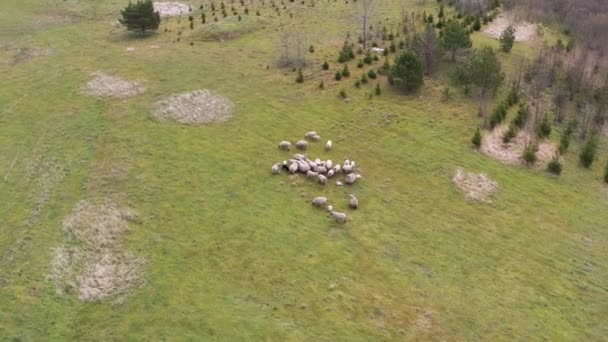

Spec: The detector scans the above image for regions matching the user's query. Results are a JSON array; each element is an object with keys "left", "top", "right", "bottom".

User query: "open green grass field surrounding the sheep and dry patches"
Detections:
[{"left": 0, "top": 0, "right": 608, "bottom": 341}]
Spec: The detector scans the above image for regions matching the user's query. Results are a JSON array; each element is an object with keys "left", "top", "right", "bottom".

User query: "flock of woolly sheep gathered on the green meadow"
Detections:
[{"left": 272, "top": 131, "right": 361, "bottom": 222}]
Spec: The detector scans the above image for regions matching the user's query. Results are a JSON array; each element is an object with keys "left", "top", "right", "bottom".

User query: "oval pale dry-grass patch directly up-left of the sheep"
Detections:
[{"left": 154, "top": 89, "right": 234, "bottom": 125}]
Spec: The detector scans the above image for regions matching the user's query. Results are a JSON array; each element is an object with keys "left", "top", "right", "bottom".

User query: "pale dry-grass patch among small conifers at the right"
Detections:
[{"left": 480, "top": 125, "right": 557, "bottom": 166}]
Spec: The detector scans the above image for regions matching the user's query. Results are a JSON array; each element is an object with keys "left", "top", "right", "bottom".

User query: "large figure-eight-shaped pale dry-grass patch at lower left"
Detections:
[{"left": 51, "top": 201, "right": 145, "bottom": 302}]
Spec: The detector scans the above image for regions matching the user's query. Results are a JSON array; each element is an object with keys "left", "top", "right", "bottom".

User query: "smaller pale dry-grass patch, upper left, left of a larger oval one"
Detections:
[{"left": 83, "top": 71, "right": 146, "bottom": 99}]
